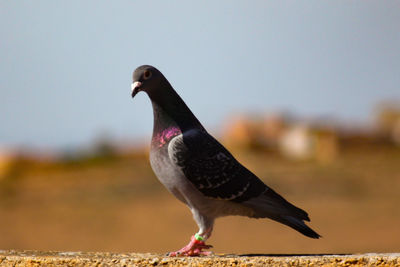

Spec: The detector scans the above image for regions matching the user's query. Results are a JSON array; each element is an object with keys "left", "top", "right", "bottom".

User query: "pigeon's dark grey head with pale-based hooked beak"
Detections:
[{"left": 131, "top": 65, "right": 165, "bottom": 98}]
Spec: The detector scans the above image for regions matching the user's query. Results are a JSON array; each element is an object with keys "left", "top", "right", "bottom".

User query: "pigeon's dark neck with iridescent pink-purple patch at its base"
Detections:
[{"left": 149, "top": 87, "right": 204, "bottom": 144}]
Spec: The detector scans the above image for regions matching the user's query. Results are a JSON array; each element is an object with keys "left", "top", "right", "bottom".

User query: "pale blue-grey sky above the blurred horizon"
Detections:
[{"left": 0, "top": 0, "right": 400, "bottom": 148}]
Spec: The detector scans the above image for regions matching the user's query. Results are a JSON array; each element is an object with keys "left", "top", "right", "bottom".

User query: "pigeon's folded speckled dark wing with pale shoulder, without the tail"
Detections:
[{"left": 168, "top": 129, "right": 268, "bottom": 203}]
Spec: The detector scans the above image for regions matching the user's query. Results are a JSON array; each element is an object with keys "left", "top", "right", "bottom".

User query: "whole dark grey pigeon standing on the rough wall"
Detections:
[{"left": 131, "top": 65, "right": 321, "bottom": 256}]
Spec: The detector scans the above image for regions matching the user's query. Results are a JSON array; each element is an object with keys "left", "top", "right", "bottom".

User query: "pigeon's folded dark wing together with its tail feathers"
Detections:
[{"left": 168, "top": 130, "right": 320, "bottom": 238}]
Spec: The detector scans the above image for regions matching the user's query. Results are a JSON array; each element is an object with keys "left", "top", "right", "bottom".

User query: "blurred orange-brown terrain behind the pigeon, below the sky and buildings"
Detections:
[{"left": 0, "top": 140, "right": 400, "bottom": 254}]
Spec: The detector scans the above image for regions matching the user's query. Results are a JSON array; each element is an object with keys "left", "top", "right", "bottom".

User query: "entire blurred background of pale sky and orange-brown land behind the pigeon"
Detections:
[{"left": 0, "top": 0, "right": 400, "bottom": 253}]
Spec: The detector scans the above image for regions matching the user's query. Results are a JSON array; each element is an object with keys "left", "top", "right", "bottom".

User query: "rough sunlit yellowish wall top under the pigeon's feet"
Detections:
[{"left": 0, "top": 250, "right": 400, "bottom": 266}]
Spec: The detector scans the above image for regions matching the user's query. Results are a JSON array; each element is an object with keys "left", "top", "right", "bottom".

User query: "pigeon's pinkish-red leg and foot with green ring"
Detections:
[{"left": 168, "top": 228, "right": 212, "bottom": 257}]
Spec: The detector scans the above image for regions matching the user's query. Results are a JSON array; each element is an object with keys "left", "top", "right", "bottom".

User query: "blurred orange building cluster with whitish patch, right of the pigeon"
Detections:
[{"left": 223, "top": 114, "right": 339, "bottom": 162}]
